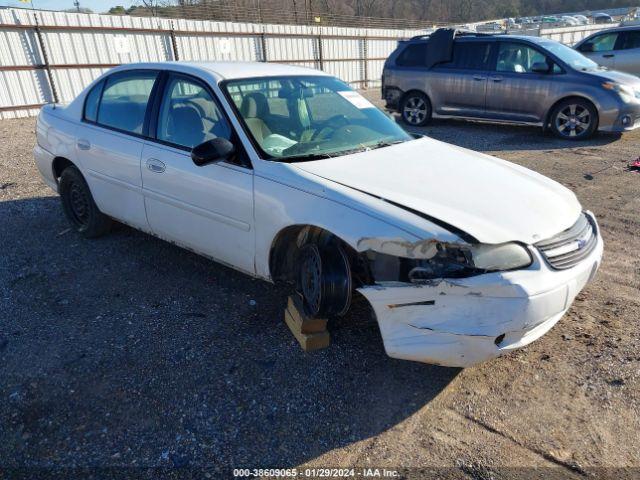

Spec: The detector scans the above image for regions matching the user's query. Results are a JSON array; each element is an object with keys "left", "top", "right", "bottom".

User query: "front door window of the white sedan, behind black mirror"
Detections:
[{"left": 156, "top": 77, "right": 231, "bottom": 148}]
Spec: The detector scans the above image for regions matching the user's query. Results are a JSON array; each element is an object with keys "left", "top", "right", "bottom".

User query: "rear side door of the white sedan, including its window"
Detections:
[{"left": 76, "top": 70, "right": 158, "bottom": 230}]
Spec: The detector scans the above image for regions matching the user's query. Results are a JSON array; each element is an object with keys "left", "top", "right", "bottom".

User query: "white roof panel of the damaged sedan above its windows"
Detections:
[{"left": 105, "top": 61, "right": 328, "bottom": 80}]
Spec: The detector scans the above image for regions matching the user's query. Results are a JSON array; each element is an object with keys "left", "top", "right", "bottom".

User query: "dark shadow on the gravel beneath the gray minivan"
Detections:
[{"left": 396, "top": 115, "right": 621, "bottom": 152}]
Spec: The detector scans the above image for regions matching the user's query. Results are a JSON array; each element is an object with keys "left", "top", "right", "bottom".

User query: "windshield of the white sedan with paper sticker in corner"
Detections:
[{"left": 224, "top": 76, "right": 412, "bottom": 162}]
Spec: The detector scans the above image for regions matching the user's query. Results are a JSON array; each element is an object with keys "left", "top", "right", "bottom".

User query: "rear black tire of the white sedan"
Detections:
[{"left": 58, "top": 167, "right": 113, "bottom": 238}]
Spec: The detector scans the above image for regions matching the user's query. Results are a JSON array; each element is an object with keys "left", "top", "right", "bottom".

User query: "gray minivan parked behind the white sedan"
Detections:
[{"left": 382, "top": 30, "right": 640, "bottom": 140}]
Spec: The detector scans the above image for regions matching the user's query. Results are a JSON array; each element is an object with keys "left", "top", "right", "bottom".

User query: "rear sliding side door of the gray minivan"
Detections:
[{"left": 428, "top": 40, "right": 493, "bottom": 118}]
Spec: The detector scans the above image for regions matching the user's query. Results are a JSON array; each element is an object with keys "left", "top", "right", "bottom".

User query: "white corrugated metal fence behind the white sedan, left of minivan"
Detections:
[{"left": 0, "top": 9, "right": 422, "bottom": 118}]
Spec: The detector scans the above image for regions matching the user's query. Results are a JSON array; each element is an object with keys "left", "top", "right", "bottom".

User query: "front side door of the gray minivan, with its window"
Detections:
[{"left": 487, "top": 41, "right": 562, "bottom": 123}]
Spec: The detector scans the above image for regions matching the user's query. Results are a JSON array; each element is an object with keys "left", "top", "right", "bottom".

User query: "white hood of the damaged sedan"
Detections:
[{"left": 294, "top": 138, "right": 581, "bottom": 244}]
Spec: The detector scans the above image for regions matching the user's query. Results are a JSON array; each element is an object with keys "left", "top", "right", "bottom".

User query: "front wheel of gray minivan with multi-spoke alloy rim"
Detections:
[{"left": 549, "top": 98, "right": 598, "bottom": 140}]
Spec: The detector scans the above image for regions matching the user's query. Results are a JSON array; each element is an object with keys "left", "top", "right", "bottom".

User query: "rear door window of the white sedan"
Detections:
[{"left": 97, "top": 71, "right": 158, "bottom": 134}]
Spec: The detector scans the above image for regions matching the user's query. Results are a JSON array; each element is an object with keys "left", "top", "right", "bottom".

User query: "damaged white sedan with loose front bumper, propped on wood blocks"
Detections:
[{"left": 35, "top": 63, "right": 603, "bottom": 367}]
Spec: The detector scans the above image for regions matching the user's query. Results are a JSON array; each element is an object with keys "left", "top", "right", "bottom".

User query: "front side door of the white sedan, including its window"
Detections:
[{"left": 141, "top": 73, "right": 255, "bottom": 274}]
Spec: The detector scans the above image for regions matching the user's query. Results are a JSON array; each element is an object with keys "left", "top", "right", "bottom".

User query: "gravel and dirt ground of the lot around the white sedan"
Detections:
[{"left": 0, "top": 95, "right": 640, "bottom": 478}]
